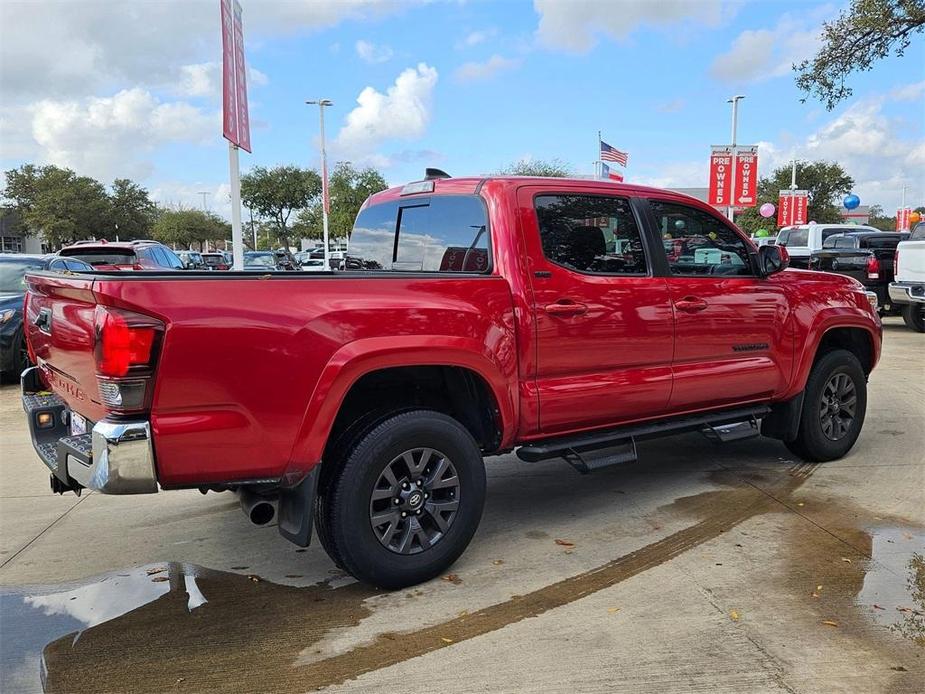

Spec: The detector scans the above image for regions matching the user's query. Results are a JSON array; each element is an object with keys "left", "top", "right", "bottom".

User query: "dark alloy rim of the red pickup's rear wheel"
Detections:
[{"left": 369, "top": 448, "right": 459, "bottom": 554}]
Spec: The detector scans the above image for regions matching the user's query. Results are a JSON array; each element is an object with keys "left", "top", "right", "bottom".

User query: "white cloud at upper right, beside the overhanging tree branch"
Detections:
[{"left": 710, "top": 15, "right": 820, "bottom": 83}]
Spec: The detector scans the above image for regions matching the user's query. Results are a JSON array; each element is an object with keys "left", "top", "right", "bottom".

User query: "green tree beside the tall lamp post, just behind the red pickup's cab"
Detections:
[{"left": 296, "top": 161, "right": 389, "bottom": 239}]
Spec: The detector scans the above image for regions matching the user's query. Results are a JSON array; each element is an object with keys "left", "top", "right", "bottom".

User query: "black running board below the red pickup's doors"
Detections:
[{"left": 517, "top": 405, "right": 771, "bottom": 470}]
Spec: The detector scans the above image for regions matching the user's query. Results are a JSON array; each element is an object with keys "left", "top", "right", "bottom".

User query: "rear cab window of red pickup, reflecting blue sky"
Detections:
[{"left": 344, "top": 195, "right": 491, "bottom": 272}]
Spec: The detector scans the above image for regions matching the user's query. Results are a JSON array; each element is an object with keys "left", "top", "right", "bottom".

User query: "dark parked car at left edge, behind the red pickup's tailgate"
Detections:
[{"left": 0, "top": 253, "right": 93, "bottom": 380}]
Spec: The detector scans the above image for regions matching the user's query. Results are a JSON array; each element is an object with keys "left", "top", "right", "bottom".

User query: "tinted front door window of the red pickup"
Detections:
[{"left": 650, "top": 200, "right": 752, "bottom": 275}]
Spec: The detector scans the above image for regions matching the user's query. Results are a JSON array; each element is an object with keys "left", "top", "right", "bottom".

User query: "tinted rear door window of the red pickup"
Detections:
[{"left": 534, "top": 195, "right": 647, "bottom": 275}]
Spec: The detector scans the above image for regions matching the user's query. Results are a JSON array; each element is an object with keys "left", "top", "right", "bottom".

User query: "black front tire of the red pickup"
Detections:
[{"left": 785, "top": 349, "right": 867, "bottom": 463}]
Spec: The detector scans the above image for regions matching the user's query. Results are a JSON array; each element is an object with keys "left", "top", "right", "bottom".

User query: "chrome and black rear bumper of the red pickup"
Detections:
[{"left": 21, "top": 367, "right": 157, "bottom": 494}]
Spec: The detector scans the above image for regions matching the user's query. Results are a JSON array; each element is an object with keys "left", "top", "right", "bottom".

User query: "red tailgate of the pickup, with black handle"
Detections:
[{"left": 23, "top": 273, "right": 106, "bottom": 421}]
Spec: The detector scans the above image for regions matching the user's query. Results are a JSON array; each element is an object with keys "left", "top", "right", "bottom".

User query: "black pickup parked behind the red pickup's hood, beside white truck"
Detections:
[{"left": 809, "top": 231, "right": 909, "bottom": 313}]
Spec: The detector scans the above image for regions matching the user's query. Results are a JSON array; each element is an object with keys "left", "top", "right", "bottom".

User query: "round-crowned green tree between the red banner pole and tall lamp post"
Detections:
[{"left": 241, "top": 166, "right": 321, "bottom": 248}]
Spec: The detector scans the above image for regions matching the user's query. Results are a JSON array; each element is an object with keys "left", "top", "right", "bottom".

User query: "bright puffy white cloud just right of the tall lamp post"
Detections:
[{"left": 334, "top": 63, "right": 437, "bottom": 156}]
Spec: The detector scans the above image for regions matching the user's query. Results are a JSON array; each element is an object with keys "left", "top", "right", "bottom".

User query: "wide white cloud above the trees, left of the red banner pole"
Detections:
[{"left": 23, "top": 88, "right": 221, "bottom": 181}]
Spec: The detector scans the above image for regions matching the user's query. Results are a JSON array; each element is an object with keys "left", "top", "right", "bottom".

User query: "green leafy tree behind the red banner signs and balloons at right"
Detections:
[{"left": 735, "top": 161, "right": 854, "bottom": 234}]
